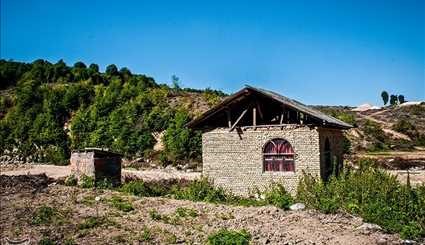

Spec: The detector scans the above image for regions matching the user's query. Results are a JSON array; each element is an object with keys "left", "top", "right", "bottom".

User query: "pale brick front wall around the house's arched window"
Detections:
[{"left": 202, "top": 125, "right": 320, "bottom": 195}]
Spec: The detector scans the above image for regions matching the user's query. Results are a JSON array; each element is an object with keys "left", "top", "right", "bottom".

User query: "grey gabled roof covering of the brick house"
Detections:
[{"left": 187, "top": 85, "right": 353, "bottom": 129}]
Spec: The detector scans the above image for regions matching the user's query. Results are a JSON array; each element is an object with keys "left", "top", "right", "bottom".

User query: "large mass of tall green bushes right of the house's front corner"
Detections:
[{"left": 297, "top": 160, "right": 425, "bottom": 239}]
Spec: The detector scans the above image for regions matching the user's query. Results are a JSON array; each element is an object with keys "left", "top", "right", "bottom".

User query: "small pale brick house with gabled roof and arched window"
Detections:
[{"left": 187, "top": 86, "right": 352, "bottom": 195}]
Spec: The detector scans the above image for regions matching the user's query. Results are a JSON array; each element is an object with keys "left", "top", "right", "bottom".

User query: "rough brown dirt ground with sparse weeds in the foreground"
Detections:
[{"left": 0, "top": 176, "right": 400, "bottom": 244}]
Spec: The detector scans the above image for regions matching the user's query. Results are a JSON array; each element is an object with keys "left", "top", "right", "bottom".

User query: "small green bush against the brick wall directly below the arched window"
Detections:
[{"left": 264, "top": 183, "right": 294, "bottom": 209}]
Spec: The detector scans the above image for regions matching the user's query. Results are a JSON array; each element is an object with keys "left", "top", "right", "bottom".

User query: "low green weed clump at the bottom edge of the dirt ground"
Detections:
[{"left": 208, "top": 229, "right": 251, "bottom": 245}]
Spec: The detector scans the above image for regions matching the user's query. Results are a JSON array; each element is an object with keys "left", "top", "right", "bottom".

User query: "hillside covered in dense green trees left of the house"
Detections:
[{"left": 0, "top": 60, "right": 225, "bottom": 164}]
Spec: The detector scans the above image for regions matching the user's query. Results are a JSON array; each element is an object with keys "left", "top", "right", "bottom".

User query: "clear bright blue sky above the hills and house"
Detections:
[{"left": 0, "top": 0, "right": 425, "bottom": 105}]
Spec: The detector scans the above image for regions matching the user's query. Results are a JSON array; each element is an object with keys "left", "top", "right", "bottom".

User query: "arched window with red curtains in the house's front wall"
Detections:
[{"left": 263, "top": 139, "right": 295, "bottom": 172}]
